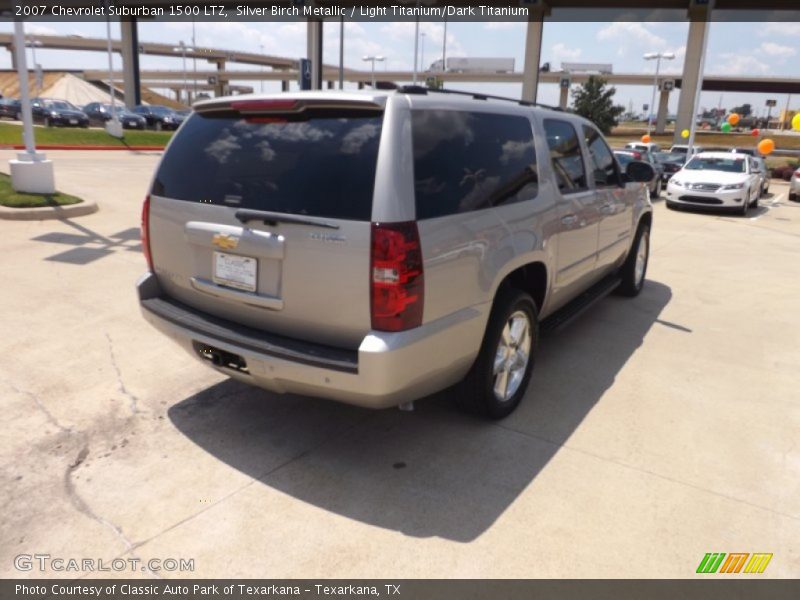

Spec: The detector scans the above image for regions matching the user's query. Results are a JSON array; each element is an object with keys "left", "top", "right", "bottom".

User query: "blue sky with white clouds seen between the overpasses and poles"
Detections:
[{"left": 0, "top": 20, "right": 800, "bottom": 114}]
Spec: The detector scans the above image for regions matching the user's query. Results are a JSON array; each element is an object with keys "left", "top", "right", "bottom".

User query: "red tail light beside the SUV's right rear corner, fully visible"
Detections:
[{"left": 370, "top": 221, "right": 425, "bottom": 331}]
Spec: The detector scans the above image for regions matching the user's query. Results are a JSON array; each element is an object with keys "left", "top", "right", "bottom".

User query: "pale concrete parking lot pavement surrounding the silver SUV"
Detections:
[{"left": 0, "top": 150, "right": 800, "bottom": 578}]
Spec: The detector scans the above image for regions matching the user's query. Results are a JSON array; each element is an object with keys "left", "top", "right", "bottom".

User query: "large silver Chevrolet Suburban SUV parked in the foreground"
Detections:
[{"left": 138, "top": 87, "right": 653, "bottom": 418}]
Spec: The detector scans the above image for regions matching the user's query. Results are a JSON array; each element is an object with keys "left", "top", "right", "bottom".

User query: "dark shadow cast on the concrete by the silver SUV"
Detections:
[{"left": 169, "top": 281, "right": 676, "bottom": 542}]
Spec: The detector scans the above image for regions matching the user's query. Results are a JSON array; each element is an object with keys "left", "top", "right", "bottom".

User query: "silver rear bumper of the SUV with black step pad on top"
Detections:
[{"left": 137, "top": 273, "right": 490, "bottom": 408}]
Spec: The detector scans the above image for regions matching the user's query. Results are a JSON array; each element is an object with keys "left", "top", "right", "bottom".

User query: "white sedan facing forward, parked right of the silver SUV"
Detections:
[{"left": 667, "top": 152, "right": 761, "bottom": 215}]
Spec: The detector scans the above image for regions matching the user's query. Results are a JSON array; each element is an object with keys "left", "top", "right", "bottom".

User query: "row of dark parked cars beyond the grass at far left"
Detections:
[{"left": 0, "top": 98, "right": 188, "bottom": 131}]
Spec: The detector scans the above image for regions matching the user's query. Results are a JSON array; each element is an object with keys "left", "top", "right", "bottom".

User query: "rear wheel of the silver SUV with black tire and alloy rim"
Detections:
[{"left": 454, "top": 287, "right": 539, "bottom": 419}]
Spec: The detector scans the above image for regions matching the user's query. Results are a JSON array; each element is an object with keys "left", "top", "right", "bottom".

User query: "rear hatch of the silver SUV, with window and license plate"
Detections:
[{"left": 149, "top": 96, "right": 390, "bottom": 348}]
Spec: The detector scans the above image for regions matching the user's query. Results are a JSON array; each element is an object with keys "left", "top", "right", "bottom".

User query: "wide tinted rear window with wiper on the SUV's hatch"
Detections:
[{"left": 153, "top": 113, "right": 383, "bottom": 221}]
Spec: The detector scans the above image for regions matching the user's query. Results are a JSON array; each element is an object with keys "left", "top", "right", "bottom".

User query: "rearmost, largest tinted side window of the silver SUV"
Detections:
[{"left": 411, "top": 110, "right": 539, "bottom": 219}]
